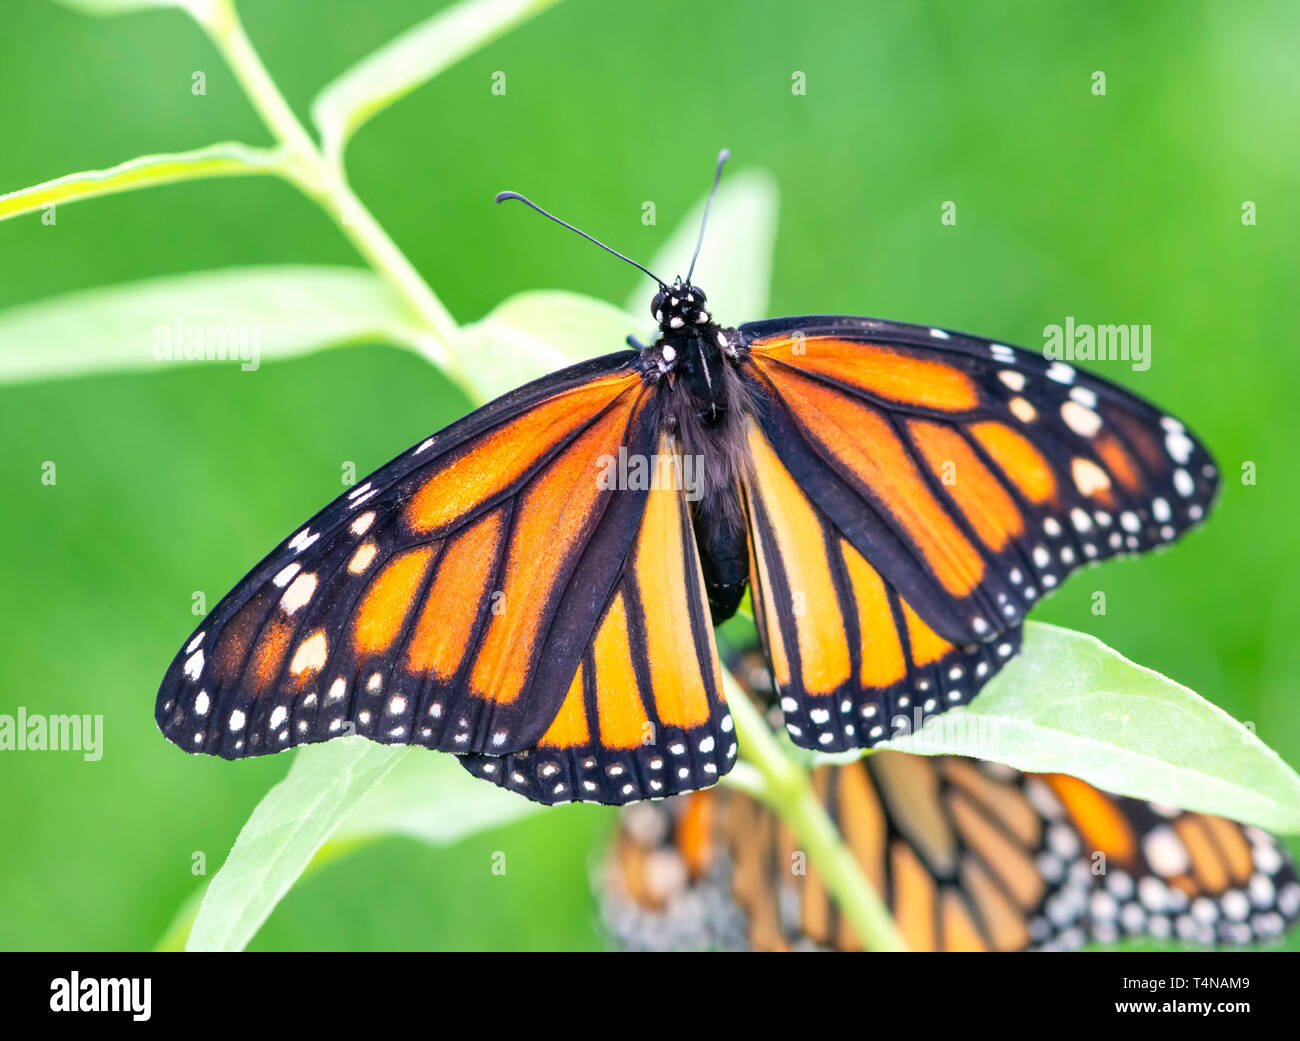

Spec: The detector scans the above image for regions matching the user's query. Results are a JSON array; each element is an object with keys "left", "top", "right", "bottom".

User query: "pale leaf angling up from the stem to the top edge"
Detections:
[{"left": 312, "top": 0, "right": 556, "bottom": 161}]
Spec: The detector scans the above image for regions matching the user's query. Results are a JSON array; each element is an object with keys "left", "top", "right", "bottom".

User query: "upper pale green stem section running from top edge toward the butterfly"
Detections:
[{"left": 195, "top": 0, "right": 472, "bottom": 391}]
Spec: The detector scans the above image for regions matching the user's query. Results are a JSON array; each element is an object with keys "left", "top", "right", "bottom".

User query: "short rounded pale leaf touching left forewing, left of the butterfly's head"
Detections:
[{"left": 458, "top": 290, "right": 645, "bottom": 400}]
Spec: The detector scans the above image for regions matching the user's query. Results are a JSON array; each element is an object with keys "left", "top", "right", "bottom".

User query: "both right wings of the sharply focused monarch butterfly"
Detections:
[{"left": 741, "top": 317, "right": 1218, "bottom": 749}]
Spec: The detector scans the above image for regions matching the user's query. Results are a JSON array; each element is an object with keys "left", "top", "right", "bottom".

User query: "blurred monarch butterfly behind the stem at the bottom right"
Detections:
[{"left": 602, "top": 655, "right": 1300, "bottom": 950}]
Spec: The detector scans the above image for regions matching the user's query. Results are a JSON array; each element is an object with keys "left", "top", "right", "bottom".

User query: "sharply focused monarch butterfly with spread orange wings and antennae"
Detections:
[{"left": 155, "top": 152, "right": 1218, "bottom": 803}]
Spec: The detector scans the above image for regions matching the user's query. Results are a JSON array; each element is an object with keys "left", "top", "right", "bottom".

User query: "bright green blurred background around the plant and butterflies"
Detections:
[{"left": 0, "top": 0, "right": 1300, "bottom": 949}]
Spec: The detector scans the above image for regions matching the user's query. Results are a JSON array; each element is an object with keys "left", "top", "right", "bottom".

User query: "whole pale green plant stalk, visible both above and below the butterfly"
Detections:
[{"left": 195, "top": 0, "right": 906, "bottom": 950}]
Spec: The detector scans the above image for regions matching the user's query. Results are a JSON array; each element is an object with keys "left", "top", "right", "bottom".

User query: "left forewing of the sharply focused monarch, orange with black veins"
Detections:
[{"left": 156, "top": 352, "right": 686, "bottom": 758}]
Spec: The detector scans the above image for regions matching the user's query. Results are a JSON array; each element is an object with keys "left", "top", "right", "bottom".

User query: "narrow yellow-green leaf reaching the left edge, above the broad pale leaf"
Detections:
[{"left": 0, "top": 142, "right": 286, "bottom": 221}]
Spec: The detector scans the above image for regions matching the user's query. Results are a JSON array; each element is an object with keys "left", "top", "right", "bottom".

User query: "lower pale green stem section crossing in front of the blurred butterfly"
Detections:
[{"left": 723, "top": 669, "right": 907, "bottom": 951}]
